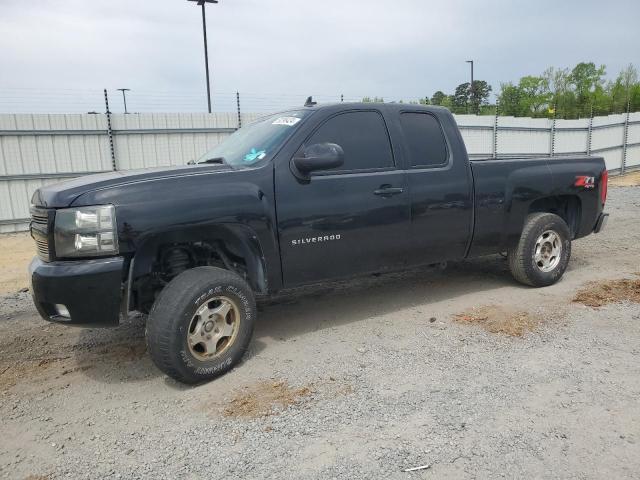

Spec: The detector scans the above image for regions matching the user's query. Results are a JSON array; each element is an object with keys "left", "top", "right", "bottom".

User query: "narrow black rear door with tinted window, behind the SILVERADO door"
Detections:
[{"left": 400, "top": 110, "right": 473, "bottom": 264}]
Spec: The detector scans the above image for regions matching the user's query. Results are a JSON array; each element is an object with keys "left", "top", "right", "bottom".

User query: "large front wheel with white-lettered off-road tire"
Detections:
[{"left": 146, "top": 267, "right": 256, "bottom": 384}]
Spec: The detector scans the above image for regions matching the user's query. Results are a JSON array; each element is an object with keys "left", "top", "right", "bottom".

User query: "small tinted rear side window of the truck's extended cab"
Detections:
[{"left": 400, "top": 112, "right": 449, "bottom": 167}]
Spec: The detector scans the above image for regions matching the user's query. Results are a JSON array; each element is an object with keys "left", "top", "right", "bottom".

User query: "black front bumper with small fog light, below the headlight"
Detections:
[{"left": 29, "top": 257, "right": 124, "bottom": 327}]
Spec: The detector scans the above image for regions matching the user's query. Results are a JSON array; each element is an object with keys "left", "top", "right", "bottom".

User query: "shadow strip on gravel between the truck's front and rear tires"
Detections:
[{"left": 255, "top": 256, "right": 512, "bottom": 342}]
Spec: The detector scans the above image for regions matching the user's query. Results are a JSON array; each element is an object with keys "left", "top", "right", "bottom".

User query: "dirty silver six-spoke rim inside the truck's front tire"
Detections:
[{"left": 187, "top": 296, "right": 240, "bottom": 361}]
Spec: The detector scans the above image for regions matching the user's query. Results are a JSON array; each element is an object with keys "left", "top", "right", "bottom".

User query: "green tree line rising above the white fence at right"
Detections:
[{"left": 362, "top": 62, "right": 640, "bottom": 119}]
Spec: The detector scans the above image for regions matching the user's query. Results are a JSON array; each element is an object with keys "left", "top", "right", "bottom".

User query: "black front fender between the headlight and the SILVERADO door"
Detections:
[{"left": 69, "top": 164, "right": 282, "bottom": 302}]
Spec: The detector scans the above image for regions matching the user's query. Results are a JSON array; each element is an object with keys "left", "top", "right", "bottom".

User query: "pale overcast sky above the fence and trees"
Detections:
[{"left": 0, "top": 0, "right": 640, "bottom": 112}]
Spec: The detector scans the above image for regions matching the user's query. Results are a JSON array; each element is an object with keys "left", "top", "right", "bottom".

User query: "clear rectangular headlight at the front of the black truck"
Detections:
[{"left": 54, "top": 205, "right": 118, "bottom": 258}]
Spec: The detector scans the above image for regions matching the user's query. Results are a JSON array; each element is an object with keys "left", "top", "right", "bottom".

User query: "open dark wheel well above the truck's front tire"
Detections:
[{"left": 129, "top": 228, "right": 267, "bottom": 313}]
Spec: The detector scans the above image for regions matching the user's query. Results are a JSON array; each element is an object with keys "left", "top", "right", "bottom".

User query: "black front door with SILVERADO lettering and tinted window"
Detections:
[{"left": 276, "top": 109, "right": 410, "bottom": 287}]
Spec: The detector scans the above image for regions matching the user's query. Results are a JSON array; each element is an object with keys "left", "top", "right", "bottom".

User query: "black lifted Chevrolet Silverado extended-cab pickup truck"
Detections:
[{"left": 30, "top": 103, "right": 607, "bottom": 383}]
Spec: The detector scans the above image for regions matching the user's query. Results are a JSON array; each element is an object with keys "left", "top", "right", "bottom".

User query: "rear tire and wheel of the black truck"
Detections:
[{"left": 508, "top": 213, "right": 571, "bottom": 287}]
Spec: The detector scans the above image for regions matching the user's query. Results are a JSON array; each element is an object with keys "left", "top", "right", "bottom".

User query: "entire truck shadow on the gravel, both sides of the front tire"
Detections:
[{"left": 73, "top": 256, "right": 524, "bottom": 389}]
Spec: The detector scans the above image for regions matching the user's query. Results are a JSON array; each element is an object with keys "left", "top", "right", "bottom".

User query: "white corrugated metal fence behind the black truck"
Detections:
[{"left": 0, "top": 112, "right": 640, "bottom": 233}]
